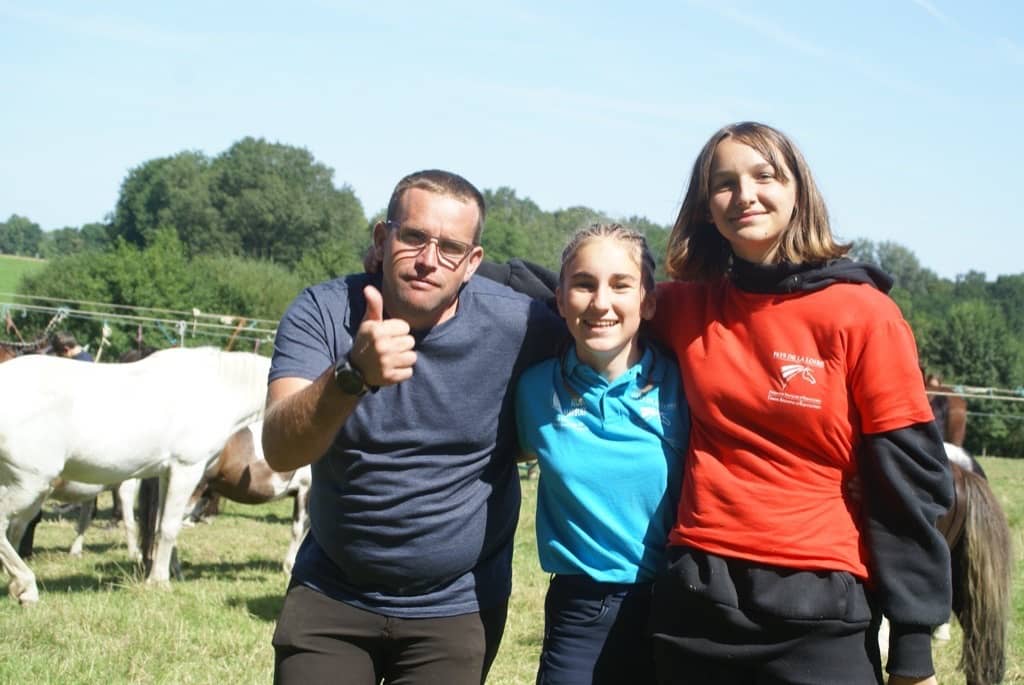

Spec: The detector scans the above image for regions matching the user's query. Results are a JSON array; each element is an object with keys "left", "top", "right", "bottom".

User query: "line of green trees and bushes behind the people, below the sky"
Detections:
[{"left": 0, "top": 138, "right": 1024, "bottom": 457}]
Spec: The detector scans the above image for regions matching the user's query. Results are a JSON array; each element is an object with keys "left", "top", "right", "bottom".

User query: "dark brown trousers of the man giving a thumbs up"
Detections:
[{"left": 273, "top": 585, "right": 508, "bottom": 685}]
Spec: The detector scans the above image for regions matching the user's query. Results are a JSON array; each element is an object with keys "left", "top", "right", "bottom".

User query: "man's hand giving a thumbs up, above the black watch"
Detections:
[{"left": 349, "top": 286, "right": 416, "bottom": 386}]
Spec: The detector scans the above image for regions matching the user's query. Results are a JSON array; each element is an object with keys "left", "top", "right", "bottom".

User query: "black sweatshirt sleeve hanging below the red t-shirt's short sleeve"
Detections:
[{"left": 859, "top": 421, "right": 953, "bottom": 677}]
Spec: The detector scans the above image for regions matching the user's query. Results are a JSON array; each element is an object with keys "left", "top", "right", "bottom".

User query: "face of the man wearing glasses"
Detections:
[{"left": 374, "top": 188, "right": 483, "bottom": 330}]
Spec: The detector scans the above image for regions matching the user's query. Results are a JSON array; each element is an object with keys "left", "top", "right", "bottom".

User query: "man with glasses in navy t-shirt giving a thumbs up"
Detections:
[{"left": 263, "top": 170, "right": 564, "bottom": 685}]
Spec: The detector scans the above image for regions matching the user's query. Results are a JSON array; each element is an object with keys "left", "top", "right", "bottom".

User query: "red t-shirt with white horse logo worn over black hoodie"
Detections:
[{"left": 654, "top": 282, "right": 933, "bottom": 579}]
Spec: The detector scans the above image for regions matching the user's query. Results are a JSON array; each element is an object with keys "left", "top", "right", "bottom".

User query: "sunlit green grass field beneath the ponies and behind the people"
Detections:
[{"left": 0, "top": 458, "right": 1024, "bottom": 685}]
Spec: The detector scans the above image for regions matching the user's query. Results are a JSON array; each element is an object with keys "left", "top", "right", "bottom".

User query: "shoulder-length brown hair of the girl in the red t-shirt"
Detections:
[{"left": 665, "top": 122, "right": 850, "bottom": 282}]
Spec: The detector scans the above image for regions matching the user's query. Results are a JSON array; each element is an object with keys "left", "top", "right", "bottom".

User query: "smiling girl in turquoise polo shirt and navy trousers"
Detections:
[{"left": 516, "top": 224, "right": 689, "bottom": 685}]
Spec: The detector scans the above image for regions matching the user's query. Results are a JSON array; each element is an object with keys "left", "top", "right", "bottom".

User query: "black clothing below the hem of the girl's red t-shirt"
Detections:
[{"left": 651, "top": 548, "right": 883, "bottom": 685}]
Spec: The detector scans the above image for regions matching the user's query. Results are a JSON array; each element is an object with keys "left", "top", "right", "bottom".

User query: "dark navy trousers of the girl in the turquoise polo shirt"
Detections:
[{"left": 537, "top": 575, "right": 654, "bottom": 685}]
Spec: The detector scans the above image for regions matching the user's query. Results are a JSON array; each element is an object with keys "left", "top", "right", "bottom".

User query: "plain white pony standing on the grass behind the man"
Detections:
[{"left": 0, "top": 348, "right": 270, "bottom": 604}]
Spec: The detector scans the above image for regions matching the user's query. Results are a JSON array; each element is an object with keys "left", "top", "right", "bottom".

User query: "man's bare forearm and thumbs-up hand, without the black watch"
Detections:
[{"left": 262, "top": 286, "right": 416, "bottom": 471}]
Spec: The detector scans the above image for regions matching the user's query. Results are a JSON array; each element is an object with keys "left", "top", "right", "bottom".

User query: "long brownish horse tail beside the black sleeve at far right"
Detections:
[{"left": 952, "top": 471, "right": 1013, "bottom": 685}]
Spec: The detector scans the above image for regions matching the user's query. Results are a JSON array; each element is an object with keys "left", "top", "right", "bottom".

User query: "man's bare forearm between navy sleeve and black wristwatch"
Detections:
[{"left": 263, "top": 369, "right": 359, "bottom": 471}]
